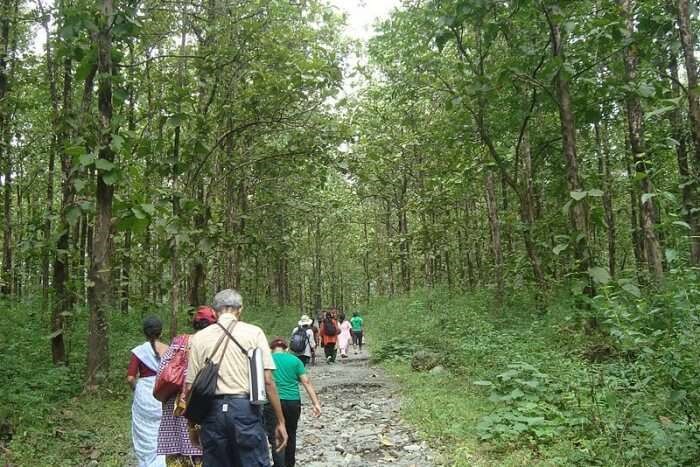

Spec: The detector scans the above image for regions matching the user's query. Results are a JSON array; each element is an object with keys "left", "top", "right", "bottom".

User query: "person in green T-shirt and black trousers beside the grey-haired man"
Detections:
[{"left": 265, "top": 338, "right": 321, "bottom": 467}]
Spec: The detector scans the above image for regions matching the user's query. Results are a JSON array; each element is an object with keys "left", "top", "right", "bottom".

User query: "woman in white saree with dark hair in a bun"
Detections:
[{"left": 126, "top": 316, "right": 168, "bottom": 467}]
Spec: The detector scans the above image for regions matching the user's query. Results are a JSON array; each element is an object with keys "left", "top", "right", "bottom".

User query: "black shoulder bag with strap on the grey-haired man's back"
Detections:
[{"left": 183, "top": 321, "right": 238, "bottom": 425}]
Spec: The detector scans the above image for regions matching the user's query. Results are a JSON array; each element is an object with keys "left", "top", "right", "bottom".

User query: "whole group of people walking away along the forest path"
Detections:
[{"left": 127, "top": 289, "right": 364, "bottom": 467}]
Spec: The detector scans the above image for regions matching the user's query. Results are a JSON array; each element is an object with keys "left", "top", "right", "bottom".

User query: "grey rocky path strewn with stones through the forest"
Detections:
[{"left": 297, "top": 350, "right": 434, "bottom": 467}]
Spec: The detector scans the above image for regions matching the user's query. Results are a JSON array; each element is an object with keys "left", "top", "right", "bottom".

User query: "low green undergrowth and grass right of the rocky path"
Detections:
[{"left": 368, "top": 276, "right": 700, "bottom": 466}]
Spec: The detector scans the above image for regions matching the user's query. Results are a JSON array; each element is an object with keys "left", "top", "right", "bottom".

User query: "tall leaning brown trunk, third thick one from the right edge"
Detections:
[{"left": 545, "top": 11, "right": 592, "bottom": 278}]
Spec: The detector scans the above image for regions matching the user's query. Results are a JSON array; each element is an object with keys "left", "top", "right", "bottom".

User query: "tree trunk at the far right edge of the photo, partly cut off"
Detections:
[{"left": 676, "top": 0, "right": 700, "bottom": 266}]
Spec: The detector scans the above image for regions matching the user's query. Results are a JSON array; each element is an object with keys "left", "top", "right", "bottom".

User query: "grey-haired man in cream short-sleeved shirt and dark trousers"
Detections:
[{"left": 184, "top": 289, "right": 287, "bottom": 467}]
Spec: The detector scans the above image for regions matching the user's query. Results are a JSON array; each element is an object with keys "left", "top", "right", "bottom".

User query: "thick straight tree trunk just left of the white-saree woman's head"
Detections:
[{"left": 87, "top": 0, "right": 114, "bottom": 387}]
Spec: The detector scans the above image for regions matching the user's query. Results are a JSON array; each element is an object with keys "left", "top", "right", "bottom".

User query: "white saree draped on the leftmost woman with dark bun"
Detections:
[{"left": 131, "top": 342, "right": 165, "bottom": 467}]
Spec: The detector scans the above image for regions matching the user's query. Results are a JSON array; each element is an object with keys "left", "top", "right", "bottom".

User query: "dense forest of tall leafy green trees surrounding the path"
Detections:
[{"left": 0, "top": 0, "right": 700, "bottom": 465}]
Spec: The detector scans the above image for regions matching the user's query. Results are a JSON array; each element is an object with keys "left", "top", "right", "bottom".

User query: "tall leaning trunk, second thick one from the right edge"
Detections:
[{"left": 621, "top": 0, "right": 664, "bottom": 282}]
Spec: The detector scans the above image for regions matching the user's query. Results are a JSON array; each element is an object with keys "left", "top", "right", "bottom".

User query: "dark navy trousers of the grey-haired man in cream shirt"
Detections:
[{"left": 200, "top": 397, "right": 270, "bottom": 467}]
